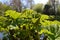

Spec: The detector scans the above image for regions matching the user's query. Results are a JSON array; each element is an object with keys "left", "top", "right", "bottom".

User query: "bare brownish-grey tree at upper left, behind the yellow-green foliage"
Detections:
[{"left": 10, "top": 0, "right": 22, "bottom": 12}]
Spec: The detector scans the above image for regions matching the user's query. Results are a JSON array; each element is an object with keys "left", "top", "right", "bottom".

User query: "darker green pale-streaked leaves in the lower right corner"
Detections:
[{"left": 47, "top": 24, "right": 60, "bottom": 40}]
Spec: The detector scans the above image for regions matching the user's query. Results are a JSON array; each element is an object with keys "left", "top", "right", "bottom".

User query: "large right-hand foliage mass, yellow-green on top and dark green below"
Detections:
[{"left": 40, "top": 16, "right": 60, "bottom": 40}]
